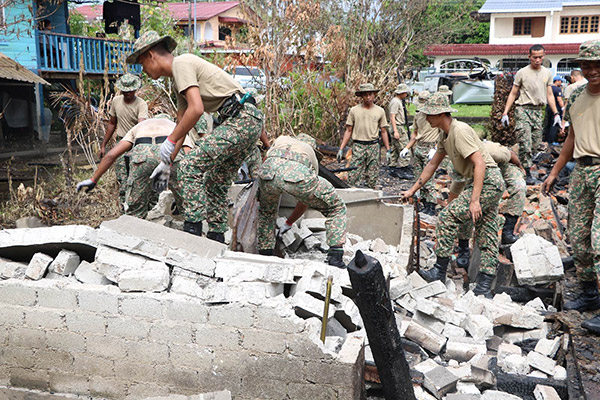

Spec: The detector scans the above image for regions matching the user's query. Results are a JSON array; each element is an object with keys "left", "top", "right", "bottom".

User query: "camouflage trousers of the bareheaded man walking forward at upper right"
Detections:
[{"left": 515, "top": 106, "right": 544, "bottom": 169}]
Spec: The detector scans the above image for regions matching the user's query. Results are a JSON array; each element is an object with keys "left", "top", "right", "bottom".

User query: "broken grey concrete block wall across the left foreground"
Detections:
[{"left": 0, "top": 279, "right": 364, "bottom": 400}]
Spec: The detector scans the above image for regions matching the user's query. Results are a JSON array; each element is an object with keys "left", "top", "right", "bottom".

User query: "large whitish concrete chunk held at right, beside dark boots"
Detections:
[{"left": 510, "top": 234, "right": 564, "bottom": 285}]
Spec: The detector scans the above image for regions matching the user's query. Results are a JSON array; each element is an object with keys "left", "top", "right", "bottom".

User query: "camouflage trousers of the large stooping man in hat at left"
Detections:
[{"left": 183, "top": 104, "right": 263, "bottom": 233}]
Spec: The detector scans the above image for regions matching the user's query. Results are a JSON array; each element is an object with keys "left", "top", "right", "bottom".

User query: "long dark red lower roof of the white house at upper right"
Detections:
[{"left": 423, "top": 43, "right": 580, "bottom": 56}]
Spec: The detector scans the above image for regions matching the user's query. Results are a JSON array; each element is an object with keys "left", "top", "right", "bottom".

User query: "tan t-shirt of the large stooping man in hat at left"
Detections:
[{"left": 173, "top": 54, "right": 246, "bottom": 112}]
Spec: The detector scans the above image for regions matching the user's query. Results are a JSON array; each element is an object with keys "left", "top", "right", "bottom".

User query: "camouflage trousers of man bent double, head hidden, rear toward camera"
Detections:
[{"left": 258, "top": 153, "right": 347, "bottom": 250}]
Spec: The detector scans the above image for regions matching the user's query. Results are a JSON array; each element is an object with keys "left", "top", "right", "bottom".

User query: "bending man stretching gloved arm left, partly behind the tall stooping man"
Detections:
[{"left": 77, "top": 118, "right": 202, "bottom": 223}]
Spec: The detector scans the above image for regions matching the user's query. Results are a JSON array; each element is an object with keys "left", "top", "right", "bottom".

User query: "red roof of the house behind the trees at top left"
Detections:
[{"left": 75, "top": 1, "right": 240, "bottom": 21}]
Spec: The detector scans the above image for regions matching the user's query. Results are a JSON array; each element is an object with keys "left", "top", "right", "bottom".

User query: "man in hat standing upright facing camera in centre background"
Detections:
[{"left": 337, "top": 83, "right": 391, "bottom": 189}]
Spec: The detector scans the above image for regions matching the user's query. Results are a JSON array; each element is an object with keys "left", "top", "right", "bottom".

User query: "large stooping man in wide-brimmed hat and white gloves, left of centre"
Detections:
[{"left": 127, "top": 31, "right": 263, "bottom": 243}]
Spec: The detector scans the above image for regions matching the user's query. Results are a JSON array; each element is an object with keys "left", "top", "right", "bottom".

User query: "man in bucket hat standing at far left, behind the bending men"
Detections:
[{"left": 100, "top": 74, "right": 148, "bottom": 208}]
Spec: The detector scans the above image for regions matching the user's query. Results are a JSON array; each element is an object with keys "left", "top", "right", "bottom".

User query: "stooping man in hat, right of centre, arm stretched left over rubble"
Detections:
[{"left": 403, "top": 93, "right": 504, "bottom": 296}]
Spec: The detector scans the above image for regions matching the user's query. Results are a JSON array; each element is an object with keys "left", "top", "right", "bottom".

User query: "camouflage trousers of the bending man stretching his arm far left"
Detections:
[{"left": 125, "top": 144, "right": 202, "bottom": 220}]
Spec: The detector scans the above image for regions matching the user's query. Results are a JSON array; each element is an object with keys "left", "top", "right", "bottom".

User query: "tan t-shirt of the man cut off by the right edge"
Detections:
[{"left": 565, "top": 85, "right": 600, "bottom": 159}]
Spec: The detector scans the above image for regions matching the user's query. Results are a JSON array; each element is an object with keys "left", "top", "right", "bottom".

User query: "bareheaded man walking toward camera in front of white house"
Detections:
[{"left": 501, "top": 44, "right": 561, "bottom": 185}]
